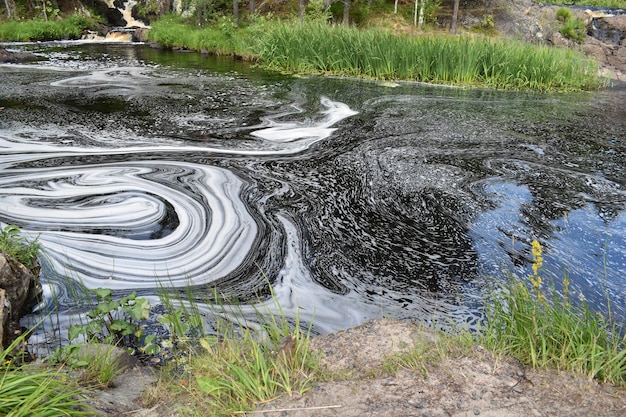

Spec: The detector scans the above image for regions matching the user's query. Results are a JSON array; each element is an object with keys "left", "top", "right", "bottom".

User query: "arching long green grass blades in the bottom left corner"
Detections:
[{"left": 0, "top": 336, "right": 94, "bottom": 417}]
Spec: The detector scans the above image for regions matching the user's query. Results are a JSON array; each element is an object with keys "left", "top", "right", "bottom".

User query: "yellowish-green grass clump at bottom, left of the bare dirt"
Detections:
[{"left": 145, "top": 294, "right": 319, "bottom": 415}]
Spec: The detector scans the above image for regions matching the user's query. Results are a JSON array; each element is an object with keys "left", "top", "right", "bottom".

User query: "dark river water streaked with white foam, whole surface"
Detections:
[{"left": 0, "top": 42, "right": 626, "bottom": 340}]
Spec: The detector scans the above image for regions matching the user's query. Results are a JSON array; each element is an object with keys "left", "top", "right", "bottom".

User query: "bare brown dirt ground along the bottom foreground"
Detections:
[{"left": 86, "top": 320, "right": 626, "bottom": 417}]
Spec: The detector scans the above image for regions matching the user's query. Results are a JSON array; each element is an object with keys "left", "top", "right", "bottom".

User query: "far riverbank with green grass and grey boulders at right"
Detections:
[{"left": 0, "top": 0, "right": 626, "bottom": 91}]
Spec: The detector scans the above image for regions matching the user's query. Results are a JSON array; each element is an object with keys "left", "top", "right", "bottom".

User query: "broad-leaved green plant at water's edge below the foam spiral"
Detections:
[{"left": 68, "top": 288, "right": 150, "bottom": 346}]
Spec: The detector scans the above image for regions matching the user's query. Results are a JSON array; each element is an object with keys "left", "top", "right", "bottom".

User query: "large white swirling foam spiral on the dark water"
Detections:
[{"left": 0, "top": 161, "right": 257, "bottom": 288}]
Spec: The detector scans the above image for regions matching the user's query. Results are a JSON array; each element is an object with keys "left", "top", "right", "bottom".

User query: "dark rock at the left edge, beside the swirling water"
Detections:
[{"left": 0, "top": 251, "right": 42, "bottom": 349}]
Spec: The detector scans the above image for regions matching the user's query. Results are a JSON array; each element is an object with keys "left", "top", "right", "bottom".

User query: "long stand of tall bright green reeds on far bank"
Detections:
[{"left": 259, "top": 22, "right": 602, "bottom": 90}]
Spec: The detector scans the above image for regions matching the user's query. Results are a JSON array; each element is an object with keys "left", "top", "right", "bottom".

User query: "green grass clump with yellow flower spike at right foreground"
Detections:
[{"left": 479, "top": 241, "right": 626, "bottom": 386}]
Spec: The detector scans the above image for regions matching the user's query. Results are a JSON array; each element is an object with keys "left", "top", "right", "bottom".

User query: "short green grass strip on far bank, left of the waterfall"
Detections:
[{"left": 0, "top": 15, "right": 95, "bottom": 42}]
